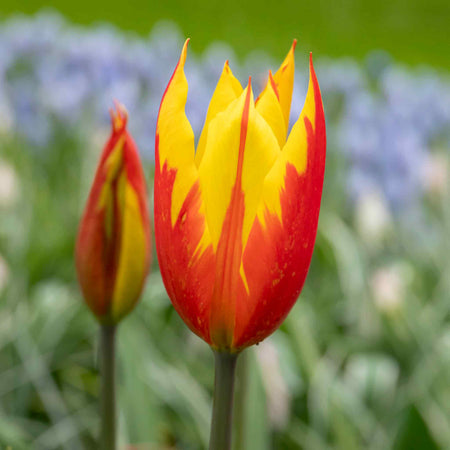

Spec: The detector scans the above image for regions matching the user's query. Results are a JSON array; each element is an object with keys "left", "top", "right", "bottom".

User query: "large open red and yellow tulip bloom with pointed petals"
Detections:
[{"left": 154, "top": 41, "right": 326, "bottom": 352}]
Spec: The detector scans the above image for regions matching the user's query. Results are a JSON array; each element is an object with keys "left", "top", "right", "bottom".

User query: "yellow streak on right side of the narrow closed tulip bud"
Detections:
[{"left": 111, "top": 171, "right": 147, "bottom": 321}]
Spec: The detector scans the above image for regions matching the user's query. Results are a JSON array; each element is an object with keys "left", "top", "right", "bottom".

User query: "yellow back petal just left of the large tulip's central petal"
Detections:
[{"left": 195, "top": 61, "right": 242, "bottom": 167}]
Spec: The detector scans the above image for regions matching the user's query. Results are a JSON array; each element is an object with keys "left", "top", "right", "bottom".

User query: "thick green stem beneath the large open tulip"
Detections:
[{"left": 209, "top": 351, "right": 238, "bottom": 450}]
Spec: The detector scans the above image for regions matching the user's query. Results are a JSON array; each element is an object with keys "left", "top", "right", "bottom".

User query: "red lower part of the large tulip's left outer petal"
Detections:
[{"left": 154, "top": 161, "right": 215, "bottom": 343}]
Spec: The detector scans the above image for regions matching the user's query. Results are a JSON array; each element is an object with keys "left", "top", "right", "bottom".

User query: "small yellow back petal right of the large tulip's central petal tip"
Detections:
[{"left": 256, "top": 72, "right": 287, "bottom": 148}]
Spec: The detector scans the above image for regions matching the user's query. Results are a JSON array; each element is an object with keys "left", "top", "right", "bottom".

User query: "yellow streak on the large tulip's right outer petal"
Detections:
[{"left": 257, "top": 59, "right": 316, "bottom": 226}]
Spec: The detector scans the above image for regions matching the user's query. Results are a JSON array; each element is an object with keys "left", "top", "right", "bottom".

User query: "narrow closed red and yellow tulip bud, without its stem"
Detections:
[{"left": 75, "top": 104, "right": 151, "bottom": 324}]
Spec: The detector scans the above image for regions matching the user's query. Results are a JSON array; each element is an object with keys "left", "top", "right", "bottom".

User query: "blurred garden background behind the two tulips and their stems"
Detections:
[{"left": 0, "top": 0, "right": 450, "bottom": 450}]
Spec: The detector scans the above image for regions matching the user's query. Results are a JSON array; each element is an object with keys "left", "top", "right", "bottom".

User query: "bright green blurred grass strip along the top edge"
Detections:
[{"left": 0, "top": 0, "right": 450, "bottom": 69}]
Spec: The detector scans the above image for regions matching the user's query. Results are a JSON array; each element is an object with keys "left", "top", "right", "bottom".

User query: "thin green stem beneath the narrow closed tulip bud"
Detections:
[{"left": 100, "top": 325, "right": 117, "bottom": 450}]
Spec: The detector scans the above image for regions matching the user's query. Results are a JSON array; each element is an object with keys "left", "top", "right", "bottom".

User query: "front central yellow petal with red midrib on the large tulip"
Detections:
[{"left": 199, "top": 81, "right": 280, "bottom": 348}]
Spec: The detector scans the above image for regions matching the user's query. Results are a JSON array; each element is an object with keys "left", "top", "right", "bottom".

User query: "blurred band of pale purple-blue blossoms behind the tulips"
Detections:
[{"left": 0, "top": 13, "right": 450, "bottom": 209}]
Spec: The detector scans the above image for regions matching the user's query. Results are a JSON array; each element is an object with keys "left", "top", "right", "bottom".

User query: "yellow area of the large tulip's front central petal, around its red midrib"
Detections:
[{"left": 199, "top": 87, "right": 280, "bottom": 249}]
